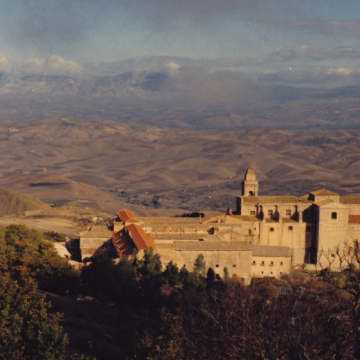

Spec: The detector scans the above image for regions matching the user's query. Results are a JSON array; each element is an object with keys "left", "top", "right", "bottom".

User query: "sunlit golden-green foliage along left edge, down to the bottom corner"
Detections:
[{"left": 0, "top": 225, "right": 77, "bottom": 360}]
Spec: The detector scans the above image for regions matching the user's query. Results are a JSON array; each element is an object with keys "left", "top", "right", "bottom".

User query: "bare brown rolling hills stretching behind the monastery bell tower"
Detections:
[{"left": 0, "top": 118, "right": 360, "bottom": 213}]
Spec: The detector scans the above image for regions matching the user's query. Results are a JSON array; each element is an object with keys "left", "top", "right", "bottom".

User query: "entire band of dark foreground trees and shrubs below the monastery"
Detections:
[{"left": 0, "top": 225, "right": 360, "bottom": 360}]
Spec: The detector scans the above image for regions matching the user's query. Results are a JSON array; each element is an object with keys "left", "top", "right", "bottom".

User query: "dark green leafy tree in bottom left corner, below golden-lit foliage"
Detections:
[{"left": 0, "top": 275, "right": 67, "bottom": 360}]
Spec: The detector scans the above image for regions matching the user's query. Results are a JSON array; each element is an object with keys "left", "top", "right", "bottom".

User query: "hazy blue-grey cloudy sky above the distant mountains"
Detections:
[{"left": 0, "top": 0, "right": 360, "bottom": 62}]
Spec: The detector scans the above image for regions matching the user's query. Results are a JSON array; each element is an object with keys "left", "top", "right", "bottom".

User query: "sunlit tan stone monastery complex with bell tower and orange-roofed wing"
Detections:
[{"left": 80, "top": 167, "right": 360, "bottom": 283}]
